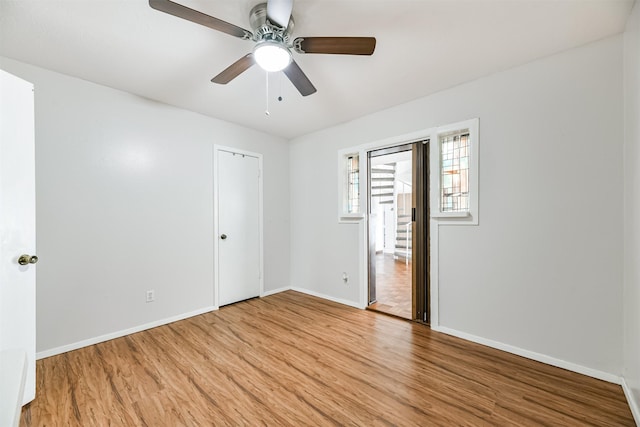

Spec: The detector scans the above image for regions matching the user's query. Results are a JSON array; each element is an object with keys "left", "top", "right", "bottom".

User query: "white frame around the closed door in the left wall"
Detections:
[{"left": 212, "top": 144, "right": 264, "bottom": 310}]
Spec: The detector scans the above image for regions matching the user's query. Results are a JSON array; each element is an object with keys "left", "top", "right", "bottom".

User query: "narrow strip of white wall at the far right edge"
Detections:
[{"left": 623, "top": 2, "right": 640, "bottom": 424}]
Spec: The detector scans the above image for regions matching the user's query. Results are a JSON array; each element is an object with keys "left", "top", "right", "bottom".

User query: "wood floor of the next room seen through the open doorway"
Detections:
[{"left": 367, "top": 253, "right": 413, "bottom": 319}]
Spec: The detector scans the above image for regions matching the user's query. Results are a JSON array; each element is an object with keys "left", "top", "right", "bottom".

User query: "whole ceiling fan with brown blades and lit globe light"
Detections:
[{"left": 149, "top": 0, "right": 376, "bottom": 96}]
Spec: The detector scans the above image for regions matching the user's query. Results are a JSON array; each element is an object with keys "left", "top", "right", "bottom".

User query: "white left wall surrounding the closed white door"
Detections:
[{"left": 0, "top": 58, "right": 289, "bottom": 354}]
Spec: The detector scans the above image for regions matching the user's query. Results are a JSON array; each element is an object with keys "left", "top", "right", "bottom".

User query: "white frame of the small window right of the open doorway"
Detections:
[{"left": 429, "top": 118, "right": 480, "bottom": 225}]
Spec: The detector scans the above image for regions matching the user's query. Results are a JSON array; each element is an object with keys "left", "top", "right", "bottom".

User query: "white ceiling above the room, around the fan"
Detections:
[{"left": 0, "top": 0, "right": 634, "bottom": 139}]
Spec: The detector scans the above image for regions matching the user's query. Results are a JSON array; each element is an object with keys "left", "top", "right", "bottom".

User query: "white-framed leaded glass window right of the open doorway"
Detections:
[{"left": 429, "top": 119, "right": 479, "bottom": 225}]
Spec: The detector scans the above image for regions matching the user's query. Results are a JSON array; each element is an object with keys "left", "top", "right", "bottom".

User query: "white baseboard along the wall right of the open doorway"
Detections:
[{"left": 431, "top": 326, "right": 622, "bottom": 384}]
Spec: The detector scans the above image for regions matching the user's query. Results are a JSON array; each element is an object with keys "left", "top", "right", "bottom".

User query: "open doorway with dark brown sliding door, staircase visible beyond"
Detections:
[{"left": 367, "top": 141, "right": 429, "bottom": 322}]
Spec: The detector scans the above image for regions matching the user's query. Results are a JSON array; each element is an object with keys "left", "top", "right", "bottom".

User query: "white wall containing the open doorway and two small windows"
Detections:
[{"left": 290, "top": 36, "right": 623, "bottom": 376}]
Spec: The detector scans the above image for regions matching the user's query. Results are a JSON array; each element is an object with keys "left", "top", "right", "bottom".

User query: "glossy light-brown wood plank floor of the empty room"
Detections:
[{"left": 21, "top": 291, "right": 634, "bottom": 427}]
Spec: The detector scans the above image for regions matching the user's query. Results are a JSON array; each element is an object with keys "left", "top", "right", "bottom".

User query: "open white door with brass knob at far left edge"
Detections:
[{"left": 0, "top": 70, "right": 37, "bottom": 412}]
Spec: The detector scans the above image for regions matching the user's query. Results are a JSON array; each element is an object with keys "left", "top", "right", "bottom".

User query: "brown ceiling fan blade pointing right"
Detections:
[{"left": 293, "top": 37, "right": 376, "bottom": 55}]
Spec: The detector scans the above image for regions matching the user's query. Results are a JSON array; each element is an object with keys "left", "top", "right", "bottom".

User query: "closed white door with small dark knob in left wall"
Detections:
[{"left": 216, "top": 150, "right": 262, "bottom": 306}]
